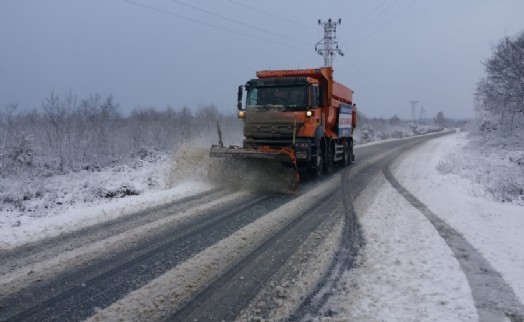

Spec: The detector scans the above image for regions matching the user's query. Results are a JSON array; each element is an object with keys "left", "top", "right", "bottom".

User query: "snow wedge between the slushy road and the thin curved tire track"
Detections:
[{"left": 323, "top": 175, "right": 478, "bottom": 321}]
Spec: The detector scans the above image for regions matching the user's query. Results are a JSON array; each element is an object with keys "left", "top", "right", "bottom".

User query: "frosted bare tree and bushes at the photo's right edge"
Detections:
[{"left": 437, "top": 32, "right": 524, "bottom": 204}]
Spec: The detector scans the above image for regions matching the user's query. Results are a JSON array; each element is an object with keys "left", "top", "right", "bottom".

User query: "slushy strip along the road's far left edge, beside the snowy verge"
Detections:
[{"left": 0, "top": 189, "right": 242, "bottom": 302}]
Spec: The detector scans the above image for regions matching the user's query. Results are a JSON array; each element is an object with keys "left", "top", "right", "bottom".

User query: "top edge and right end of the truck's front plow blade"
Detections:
[{"left": 209, "top": 145, "right": 299, "bottom": 191}]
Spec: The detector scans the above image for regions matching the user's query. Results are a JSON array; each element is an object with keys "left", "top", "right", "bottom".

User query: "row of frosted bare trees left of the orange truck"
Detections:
[{"left": 0, "top": 92, "right": 241, "bottom": 176}]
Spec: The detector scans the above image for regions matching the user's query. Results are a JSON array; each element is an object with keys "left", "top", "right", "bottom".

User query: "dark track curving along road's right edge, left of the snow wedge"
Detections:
[{"left": 241, "top": 133, "right": 447, "bottom": 321}]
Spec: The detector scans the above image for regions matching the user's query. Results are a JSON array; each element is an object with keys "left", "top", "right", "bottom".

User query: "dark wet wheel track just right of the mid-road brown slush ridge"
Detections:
[{"left": 168, "top": 189, "right": 341, "bottom": 321}]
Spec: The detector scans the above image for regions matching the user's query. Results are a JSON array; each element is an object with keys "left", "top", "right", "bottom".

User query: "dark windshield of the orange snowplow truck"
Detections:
[{"left": 246, "top": 85, "right": 308, "bottom": 111}]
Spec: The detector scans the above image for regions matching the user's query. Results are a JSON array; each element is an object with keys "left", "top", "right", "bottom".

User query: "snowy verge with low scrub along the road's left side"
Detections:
[{"left": 0, "top": 149, "right": 214, "bottom": 250}]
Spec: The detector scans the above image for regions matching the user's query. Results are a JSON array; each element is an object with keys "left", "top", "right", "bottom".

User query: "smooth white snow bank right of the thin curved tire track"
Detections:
[{"left": 394, "top": 134, "right": 524, "bottom": 302}]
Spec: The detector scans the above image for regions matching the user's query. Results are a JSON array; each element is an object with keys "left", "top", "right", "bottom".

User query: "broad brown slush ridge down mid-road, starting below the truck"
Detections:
[{"left": 85, "top": 175, "right": 338, "bottom": 321}]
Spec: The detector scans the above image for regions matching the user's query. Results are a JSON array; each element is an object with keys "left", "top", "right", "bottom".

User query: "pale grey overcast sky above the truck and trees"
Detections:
[{"left": 0, "top": 0, "right": 524, "bottom": 118}]
